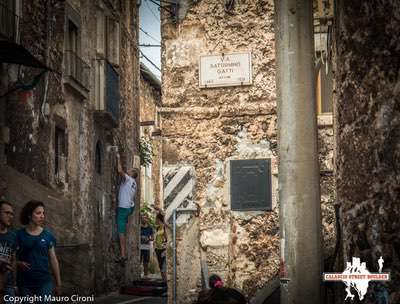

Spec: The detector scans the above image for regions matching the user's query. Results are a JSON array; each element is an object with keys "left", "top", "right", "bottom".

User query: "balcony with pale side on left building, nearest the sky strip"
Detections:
[{"left": 94, "top": 59, "right": 121, "bottom": 129}]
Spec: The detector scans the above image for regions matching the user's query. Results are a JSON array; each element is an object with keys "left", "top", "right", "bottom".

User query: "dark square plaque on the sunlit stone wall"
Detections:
[{"left": 231, "top": 159, "right": 272, "bottom": 211}]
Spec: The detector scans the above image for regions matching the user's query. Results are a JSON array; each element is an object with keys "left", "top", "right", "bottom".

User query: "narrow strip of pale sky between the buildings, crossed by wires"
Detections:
[{"left": 138, "top": 0, "right": 161, "bottom": 79}]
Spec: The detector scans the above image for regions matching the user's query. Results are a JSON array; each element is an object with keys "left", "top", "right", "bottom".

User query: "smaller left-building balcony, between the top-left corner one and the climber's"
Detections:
[{"left": 64, "top": 51, "right": 90, "bottom": 98}]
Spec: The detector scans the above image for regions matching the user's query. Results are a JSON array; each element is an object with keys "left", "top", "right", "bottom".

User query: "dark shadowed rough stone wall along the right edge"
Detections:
[{"left": 335, "top": 1, "right": 400, "bottom": 303}]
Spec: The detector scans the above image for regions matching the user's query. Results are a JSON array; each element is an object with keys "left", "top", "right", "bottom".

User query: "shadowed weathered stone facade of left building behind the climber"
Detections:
[{"left": 0, "top": 0, "right": 140, "bottom": 294}]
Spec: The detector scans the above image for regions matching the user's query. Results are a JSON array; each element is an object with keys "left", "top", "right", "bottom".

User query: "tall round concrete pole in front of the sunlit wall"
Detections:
[{"left": 275, "top": 0, "right": 322, "bottom": 304}]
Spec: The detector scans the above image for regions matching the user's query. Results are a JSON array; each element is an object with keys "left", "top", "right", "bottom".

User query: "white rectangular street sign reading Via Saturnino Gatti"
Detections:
[{"left": 199, "top": 52, "right": 252, "bottom": 88}]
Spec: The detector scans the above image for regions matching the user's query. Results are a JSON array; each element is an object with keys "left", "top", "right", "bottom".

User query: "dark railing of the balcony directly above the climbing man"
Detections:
[{"left": 105, "top": 60, "right": 121, "bottom": 122}]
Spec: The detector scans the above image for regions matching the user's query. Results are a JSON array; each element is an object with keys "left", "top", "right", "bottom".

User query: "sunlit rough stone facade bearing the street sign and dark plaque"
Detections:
[{"left": 160, "top": 0, "right": 335, "bottom": 303}]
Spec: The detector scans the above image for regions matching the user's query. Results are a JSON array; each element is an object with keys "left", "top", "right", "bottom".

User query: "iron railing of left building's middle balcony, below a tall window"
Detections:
[{"left": 65, "top": 50, "right": 90, "bottom": 89}]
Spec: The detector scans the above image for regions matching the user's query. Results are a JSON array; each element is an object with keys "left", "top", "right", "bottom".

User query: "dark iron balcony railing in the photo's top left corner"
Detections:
[{"left": 0, "top": 1, "right": 22, "bottom": 42}]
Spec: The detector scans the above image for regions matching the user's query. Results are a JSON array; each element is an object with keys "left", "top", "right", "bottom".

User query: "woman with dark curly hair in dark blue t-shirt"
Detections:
[{"left": 17, "top": 201, "right": 61, "bottom": 303}]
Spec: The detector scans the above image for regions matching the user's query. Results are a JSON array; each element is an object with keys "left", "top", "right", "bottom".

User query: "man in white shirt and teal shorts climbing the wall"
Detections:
[{"left": 116, "top": 153, "right": 138, "bottom": 263}]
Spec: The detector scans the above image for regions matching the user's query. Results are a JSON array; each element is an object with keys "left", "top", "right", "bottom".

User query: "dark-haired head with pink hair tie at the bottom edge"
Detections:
[{"left": 197, "top": 274, "right": 248, "bottom": 304}]
